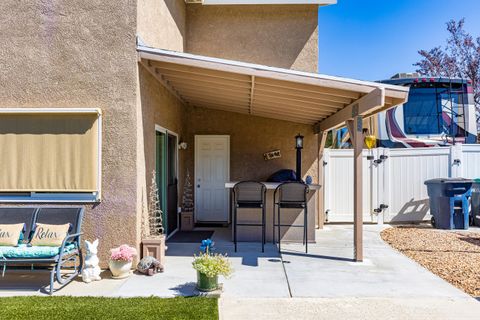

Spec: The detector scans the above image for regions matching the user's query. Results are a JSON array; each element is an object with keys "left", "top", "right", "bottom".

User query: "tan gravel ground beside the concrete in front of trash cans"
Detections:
[{"left": 381, "top": 226, "right": 480, "bottom": 297}]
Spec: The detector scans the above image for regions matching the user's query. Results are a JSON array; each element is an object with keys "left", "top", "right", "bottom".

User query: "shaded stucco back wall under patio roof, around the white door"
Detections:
[{"left": 185, "top": 107, "right": 318, "bottom": 181}]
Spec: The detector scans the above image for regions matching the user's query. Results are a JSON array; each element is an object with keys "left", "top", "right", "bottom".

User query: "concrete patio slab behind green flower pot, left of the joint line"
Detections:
[{"left": 114, "top": 242, "right": 289, "bottom": 297}]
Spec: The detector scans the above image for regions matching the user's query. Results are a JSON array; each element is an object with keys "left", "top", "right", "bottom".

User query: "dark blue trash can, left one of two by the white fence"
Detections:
[{"left": 425, "top": 178, "right": 473, "bottom": 230}]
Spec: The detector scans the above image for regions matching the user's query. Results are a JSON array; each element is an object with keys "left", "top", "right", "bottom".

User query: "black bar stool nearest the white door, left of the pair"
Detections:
[{"left": 233, "top": 181, "right": 267, "bottom": 252}]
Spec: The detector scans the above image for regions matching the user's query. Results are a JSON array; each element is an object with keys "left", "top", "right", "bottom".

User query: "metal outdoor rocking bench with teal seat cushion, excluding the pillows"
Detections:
[{"left": 0, "top": 207, "right": 84, "bottom": 295}]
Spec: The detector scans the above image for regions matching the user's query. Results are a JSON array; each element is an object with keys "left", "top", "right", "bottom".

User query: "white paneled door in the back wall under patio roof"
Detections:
[{"left": 195, "top": 135, "right": 230, "bottom": 222}]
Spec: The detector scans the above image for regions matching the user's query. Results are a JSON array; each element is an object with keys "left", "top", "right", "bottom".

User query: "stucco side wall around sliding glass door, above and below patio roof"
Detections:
[{"left": 136, "top": 0, "right": 186, "bottom": 240}]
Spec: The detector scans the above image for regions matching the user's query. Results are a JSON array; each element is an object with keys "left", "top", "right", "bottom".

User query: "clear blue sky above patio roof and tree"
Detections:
[{"left": 318, "top": 0, "right": 480, "bottom": 80}]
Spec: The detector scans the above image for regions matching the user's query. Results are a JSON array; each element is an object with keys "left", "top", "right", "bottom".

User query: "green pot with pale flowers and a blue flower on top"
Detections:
[{"left": 192, "top": 239, "right": 233, "bottom": 291}]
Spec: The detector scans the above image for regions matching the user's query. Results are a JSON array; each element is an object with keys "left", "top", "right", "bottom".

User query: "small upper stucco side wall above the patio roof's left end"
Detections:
[{"left": 137, "top": 0, "right": 186, "bottom": 52}]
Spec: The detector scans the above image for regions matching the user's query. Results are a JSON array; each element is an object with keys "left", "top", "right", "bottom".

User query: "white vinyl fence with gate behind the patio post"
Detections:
[{"left": 324, "top": 144, "right": 480, "bottom": 223}]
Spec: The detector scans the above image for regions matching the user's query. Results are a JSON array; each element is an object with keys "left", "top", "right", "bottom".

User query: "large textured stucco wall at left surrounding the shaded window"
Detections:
[{"left": 0, "top": 0, "right": 138, "bottom": 265}]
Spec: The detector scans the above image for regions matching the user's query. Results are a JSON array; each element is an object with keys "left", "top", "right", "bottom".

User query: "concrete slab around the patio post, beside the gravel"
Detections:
[{"left": 282, "top": 225, "right": 469, "bottom": 298}]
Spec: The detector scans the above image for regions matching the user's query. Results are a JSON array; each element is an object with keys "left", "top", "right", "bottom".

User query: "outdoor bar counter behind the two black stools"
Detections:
[{"left": 225, "top": 181, "right": 320, "bottom": 242}]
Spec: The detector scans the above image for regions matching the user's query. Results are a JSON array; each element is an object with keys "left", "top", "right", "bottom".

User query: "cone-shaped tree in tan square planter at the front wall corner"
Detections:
[{"left": 142, "top": 170, "right": 165, "bottom": 266}]
